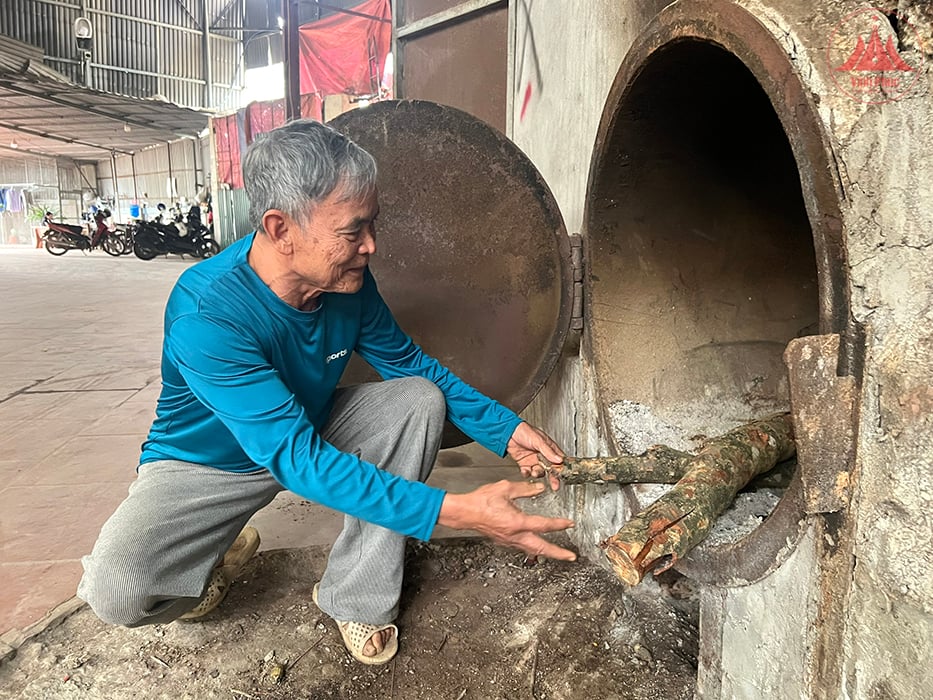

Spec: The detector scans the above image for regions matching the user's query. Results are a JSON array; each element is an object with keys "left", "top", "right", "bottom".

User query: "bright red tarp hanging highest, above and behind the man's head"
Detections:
[{"left": 298, "top": 0, "right": 392, "bottom": 98}]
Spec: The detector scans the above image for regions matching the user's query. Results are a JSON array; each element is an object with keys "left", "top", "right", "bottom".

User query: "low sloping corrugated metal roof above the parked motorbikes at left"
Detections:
[{"left": 0, "top": 36, "right": 209, "bottom": 160}]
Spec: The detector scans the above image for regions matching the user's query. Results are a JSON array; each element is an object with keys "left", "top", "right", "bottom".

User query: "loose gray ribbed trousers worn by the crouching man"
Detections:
[{"left": 78, "top": 378, "right": 446, "bottom": 627}]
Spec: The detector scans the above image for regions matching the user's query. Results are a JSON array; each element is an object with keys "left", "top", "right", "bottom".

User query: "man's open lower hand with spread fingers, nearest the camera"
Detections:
[{"left": 437, "top": 481, "right": 577, "bottom": 561}]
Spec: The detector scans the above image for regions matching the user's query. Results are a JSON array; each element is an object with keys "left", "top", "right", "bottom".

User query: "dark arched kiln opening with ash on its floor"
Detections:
[{"left": 586, "top": 38, "right": 820, "bottom": 568}]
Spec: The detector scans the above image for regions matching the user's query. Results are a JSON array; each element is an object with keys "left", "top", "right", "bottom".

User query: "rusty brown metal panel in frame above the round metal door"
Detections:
[{"left": 399, "top": 1, "right": 509, "bottom": 133}]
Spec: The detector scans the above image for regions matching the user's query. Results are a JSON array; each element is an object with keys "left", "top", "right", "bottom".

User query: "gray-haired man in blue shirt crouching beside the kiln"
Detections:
[{"left": 78, "top": 121, "right": 575, "bottom": 664}]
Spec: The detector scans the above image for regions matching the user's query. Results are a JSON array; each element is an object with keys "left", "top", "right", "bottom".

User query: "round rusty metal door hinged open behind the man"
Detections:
[{"left": 330, "top": 100, "right": 573, "bottom": 447}]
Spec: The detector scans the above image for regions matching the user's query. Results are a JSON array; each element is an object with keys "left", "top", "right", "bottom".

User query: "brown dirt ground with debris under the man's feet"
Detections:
[{"left": 0, "top": 539, "right": 697, "bottom": 700}]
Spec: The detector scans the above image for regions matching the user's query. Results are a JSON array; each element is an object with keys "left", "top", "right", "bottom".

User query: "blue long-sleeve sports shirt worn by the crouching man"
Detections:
[{"left": 140, "top": 234, "right": 521, "bottom": 540}]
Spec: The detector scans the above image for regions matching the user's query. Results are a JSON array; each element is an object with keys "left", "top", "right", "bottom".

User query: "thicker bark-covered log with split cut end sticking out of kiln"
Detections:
[{"left": 600, "top": 413, "right": 796, "bottom": 586}]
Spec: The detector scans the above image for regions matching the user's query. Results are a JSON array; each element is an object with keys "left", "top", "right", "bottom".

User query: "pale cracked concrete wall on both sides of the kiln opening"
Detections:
[{"left": 511, "top": 0, "right": 933, "bottom": 699}]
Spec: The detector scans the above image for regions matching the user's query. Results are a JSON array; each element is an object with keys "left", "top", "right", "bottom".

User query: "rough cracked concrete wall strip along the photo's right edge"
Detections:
[{"left": 830, "top": 2, "right": 933, "bottom": 698}]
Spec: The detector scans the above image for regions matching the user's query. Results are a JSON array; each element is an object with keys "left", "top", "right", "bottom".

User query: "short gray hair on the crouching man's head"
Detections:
[{"left": 243, "top": 119, "right": 376, "bottom": 231}]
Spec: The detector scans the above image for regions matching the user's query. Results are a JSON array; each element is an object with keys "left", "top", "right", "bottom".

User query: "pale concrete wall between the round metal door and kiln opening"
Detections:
[{"left": 510, "top": 0, "right": 667, "bottom": 454}]
